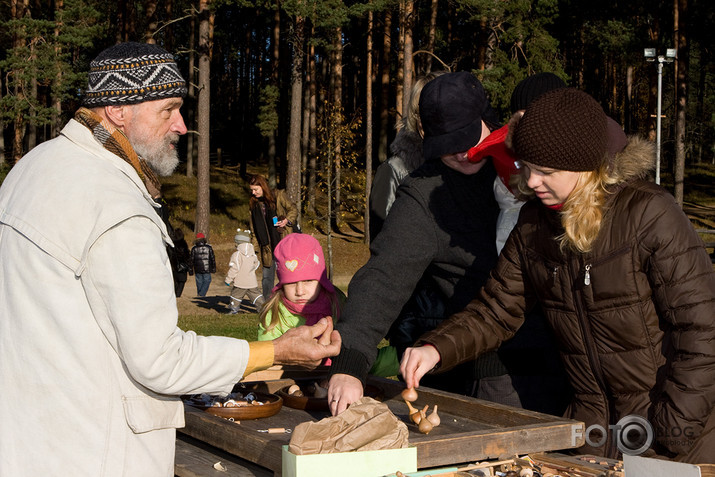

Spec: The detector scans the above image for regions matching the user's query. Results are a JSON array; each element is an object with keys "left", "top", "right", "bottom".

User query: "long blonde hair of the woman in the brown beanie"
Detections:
[{"left": 517, "top": 160, "right": 619, "bottom": 253}]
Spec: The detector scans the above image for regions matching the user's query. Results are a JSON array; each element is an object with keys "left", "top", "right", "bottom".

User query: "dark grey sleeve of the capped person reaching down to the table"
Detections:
[{"left": 330, "top": 182, "right": 439, "bottom": 381}]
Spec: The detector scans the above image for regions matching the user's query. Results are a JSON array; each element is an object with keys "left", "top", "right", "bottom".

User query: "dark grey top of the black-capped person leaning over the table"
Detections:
[{"left": 330, "top": 160, "right": 498, "bottom": 380}]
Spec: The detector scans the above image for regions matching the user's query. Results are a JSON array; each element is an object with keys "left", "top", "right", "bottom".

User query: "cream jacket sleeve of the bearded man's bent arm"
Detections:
[{"left": 81, "top": 217, "right": 249, "bottom": 395}]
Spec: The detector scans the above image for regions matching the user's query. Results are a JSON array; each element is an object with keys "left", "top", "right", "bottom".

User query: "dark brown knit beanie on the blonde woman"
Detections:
[{"left": 513, "top": 88, "right": 608, "bottom": 171}]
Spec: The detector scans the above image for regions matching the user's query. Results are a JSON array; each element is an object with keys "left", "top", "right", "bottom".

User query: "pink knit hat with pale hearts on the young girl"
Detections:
[{"left": 273, "top": 233, "right": 335, "bottom": 293}]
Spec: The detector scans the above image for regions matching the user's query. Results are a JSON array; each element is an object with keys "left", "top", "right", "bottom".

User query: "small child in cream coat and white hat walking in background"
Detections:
[{"left": 224, "top": 229, "right": 265, "bottom": 315}]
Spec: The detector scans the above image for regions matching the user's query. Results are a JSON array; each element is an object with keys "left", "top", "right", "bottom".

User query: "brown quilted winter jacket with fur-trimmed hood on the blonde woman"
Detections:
[{"left": 417, "top": 138, "right": 715, "bottom": 463}]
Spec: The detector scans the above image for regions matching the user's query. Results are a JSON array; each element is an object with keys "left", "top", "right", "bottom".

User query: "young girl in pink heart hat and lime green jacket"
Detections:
[{"left": 258, "top": 234, "right": 345, "bottom": 341}]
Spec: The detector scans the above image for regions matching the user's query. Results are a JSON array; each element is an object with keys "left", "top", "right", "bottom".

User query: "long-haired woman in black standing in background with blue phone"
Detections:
[{"left": 248, "top": 174, "right": 298, "bottom": 297}]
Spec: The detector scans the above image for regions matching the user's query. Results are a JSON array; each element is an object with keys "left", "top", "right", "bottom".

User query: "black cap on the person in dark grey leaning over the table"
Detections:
[{"left": 420, "top": 71, "right": 491, "bottom": 160}]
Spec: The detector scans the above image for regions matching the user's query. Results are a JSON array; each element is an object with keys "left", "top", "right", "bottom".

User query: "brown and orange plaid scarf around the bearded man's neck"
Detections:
[{"left": 74, "top": 108, "right": 161, "bottom": 199}]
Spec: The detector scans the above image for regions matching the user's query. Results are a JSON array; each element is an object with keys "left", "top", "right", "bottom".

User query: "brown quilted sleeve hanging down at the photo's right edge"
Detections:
[{"left": 639, "top": 192, "right": 715, "bottom": 454}]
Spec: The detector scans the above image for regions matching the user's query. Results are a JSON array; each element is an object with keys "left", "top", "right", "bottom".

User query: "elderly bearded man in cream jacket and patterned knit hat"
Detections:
[{"left": 0, "top": 43, "right": 340, "bottom": 477}]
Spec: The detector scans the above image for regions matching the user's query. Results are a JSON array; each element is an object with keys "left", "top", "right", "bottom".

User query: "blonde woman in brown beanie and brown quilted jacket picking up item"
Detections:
[{"left": 400, "top": 88, "right": 715, "bottom": 463}]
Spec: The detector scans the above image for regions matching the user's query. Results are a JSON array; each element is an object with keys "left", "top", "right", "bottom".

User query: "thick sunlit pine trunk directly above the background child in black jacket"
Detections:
[{"left": 195, "top": 0, "right": 211, "bottom": 237}]
